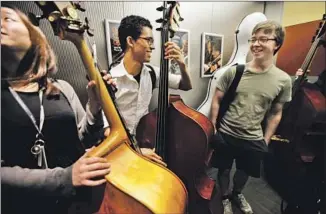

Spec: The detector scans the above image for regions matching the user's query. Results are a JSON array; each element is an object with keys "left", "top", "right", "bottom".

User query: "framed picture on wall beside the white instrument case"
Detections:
[{"left": 201, "top": 33, "right": 224, "bottom": 77}]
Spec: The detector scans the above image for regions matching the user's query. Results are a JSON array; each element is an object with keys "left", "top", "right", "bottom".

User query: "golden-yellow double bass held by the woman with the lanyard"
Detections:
[{"left": 36, "top": 2, "right": 187, "bottom": 214}]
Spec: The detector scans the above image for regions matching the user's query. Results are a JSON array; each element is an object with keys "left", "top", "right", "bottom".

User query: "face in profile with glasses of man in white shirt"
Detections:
[{"left": 131, "top": 27, "right": 154, "bottom": 63}]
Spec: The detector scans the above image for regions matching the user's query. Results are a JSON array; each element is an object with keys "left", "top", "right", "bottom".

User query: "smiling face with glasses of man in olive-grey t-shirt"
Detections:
[{"left": 250, "top": 29, "right": 279, "bottom": 61}]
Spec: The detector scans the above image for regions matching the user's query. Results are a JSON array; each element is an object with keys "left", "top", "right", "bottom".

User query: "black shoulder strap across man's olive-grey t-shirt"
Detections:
[{"left": 216, "top": 65, "right": 245, "bottom": 128}]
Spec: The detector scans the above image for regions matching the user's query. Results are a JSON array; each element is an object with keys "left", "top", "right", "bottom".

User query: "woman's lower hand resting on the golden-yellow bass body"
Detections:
[{"left": 72, "top": 146, "right": 111, "bottom": 187}]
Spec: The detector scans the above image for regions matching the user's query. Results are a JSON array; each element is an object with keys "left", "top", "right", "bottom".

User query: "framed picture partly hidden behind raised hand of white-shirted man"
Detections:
[{"left": 170, "top": 29, "right": 190, "bottom": 74}]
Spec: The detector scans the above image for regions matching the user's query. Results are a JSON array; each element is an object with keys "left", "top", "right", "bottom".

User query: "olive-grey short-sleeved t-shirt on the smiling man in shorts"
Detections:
[{"left": 216, "top": 65, "right": 292, "bottom": 140}]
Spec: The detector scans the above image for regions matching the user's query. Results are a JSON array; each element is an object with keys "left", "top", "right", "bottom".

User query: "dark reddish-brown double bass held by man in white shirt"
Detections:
[{"left": 136, "top": 2, "right": 214, "bottom": 213}]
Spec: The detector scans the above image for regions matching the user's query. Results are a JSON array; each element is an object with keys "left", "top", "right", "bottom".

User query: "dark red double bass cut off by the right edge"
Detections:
[{"left": 272, "top": 14, "right": 326, "bottom": 213}]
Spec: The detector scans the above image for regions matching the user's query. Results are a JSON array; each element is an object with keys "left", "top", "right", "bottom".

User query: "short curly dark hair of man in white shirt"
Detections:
[{"left": 118, "top": 15, "right": 153, "bottom": 51}]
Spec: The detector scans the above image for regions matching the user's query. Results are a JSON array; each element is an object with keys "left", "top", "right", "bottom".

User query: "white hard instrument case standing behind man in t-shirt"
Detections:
[{"left": 197, "top": 12, "right": 267, "bottom": 117}]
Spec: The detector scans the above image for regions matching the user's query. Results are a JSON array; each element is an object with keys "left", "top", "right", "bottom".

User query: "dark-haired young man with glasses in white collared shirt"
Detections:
[{"left": 104, "top": 15, "right": 192, "bottom": 165}]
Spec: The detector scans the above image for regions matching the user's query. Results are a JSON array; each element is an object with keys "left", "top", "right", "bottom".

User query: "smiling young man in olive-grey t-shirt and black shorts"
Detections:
[{"left": 211, "top": 21, "right": 291, "bottom": 214}]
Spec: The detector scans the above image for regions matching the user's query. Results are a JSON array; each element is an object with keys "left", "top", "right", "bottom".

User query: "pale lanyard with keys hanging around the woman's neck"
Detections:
[{"left": 9, "top": 87, "right": 48, "bottom": 168}]
